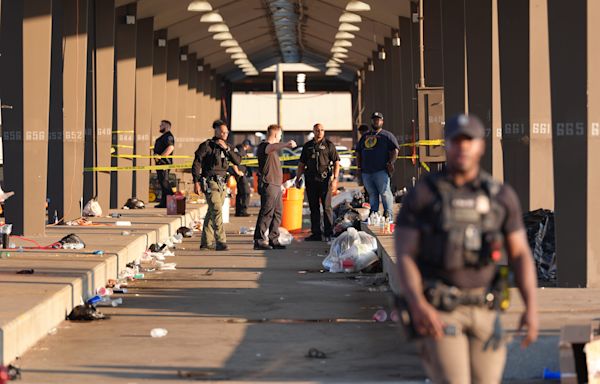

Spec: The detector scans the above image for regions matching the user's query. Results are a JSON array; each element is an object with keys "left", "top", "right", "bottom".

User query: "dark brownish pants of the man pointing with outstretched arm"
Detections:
[{"left": 254, "top": 184, "right": 283, "bottom": 244}]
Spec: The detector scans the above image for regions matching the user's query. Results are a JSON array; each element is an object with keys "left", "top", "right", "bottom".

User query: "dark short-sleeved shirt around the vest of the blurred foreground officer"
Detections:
[{"left": 396, "top": 172, "right": 524, "bottom": 288}]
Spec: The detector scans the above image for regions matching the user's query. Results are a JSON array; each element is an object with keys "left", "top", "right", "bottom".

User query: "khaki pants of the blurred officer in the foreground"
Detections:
[{"left": 417, "top": 306, "right": 506, "bottom": 384}]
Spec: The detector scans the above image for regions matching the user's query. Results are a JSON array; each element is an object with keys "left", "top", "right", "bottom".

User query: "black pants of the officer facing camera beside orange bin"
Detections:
[{"left": 306, "top": 179, "right": 333, "bottom": 236}]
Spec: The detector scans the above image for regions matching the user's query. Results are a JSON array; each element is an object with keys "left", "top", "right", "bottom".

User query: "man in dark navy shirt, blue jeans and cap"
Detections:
[{"left": 356, "top": 112, "right": 399, "bottom": 220}]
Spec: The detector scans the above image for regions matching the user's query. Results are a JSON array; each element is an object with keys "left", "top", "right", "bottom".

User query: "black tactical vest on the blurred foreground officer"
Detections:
[{"left": 419, "top": 171, "right": 507, "bottom": 271}]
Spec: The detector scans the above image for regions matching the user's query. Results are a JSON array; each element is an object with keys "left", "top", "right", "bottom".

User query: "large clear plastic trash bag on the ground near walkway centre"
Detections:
[{"left": 323, "top": 228, "right": 379, "bottom": 273}]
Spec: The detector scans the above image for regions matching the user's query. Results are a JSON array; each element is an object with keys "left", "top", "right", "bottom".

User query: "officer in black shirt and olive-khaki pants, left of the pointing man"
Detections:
[{"left": 192, "top": 120, "right": 241, "bottom": 251}]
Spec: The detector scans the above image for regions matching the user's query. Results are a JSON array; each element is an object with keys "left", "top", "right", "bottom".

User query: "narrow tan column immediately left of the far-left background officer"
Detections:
[{"left": 133, "top": 17, "right": 155, "bottom": 201}]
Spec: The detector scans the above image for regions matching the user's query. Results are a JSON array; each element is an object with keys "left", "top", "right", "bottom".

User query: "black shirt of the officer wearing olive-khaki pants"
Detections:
[{"left": 192, "top": 138, "right": 241, "bottom": 182}]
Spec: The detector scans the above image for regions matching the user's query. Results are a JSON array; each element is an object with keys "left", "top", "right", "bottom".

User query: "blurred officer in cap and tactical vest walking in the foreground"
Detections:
[{"left": 395, "top": 115, "right": 538, "bottom": 384}]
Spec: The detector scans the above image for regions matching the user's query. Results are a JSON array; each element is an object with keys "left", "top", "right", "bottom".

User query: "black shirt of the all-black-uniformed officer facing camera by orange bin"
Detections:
[{"left": 300, "top": 138, "right": 340, "bottom": 181}]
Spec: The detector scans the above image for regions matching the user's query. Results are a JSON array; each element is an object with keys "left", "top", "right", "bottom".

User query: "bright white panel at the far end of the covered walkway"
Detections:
[{"left": 231, "top": 92, "right": 352, "bottom": 132}]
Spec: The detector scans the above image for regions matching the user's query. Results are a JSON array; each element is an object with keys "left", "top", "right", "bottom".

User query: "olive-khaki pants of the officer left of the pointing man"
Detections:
[{"left": 200, "top": 180, "right": 227, "bottom": 246}]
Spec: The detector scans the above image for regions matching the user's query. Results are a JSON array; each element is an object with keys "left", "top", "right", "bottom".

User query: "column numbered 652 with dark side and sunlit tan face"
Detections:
[{"left": 48, "top": 0, "right": 87, "bottom": 220}]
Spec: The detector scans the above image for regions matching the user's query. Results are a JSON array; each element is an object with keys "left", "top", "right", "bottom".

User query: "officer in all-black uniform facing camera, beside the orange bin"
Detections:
[{"left": 296, "top": 124, "right": 340, "bottom": 241}]
